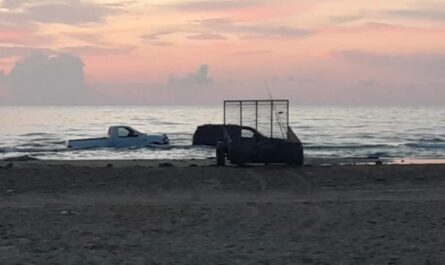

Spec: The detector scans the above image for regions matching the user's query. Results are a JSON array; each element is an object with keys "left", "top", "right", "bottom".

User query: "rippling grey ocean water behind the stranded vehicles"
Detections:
[{"left": 0, "top": 106, "right": 445, "bottom": 160}]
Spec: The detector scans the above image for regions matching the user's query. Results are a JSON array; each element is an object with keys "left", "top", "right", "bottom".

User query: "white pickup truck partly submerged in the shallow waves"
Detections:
[{"left": 67, "top": 126, "right": 169, "bottom": 149}]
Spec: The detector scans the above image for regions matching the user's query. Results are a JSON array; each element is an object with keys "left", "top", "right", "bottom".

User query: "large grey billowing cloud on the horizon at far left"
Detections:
[{"left": 1, "top": 53, "right": 88, "bottom": 105}]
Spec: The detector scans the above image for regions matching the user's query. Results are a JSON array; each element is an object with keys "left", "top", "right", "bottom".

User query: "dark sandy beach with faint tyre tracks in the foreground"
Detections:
[{"left": 0, "top": 161, "right": 445, "bottom": 265}]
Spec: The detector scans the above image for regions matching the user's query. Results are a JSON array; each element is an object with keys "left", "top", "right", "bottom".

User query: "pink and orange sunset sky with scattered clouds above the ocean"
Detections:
[{"left": 0, "top": 0, "right": 445, "bottom": 106}]
